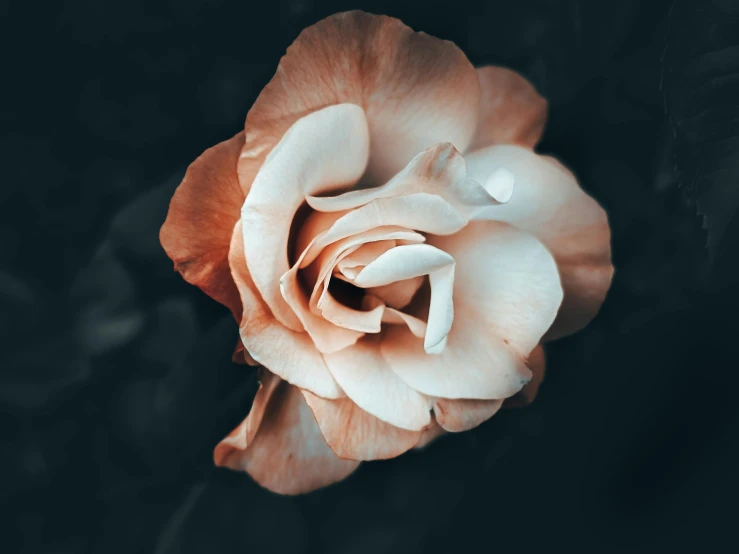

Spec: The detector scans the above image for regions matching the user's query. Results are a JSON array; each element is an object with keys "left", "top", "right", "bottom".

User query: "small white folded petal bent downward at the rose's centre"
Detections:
[{"left": 353, "top": 244, "right": 454, "bottom": 353}]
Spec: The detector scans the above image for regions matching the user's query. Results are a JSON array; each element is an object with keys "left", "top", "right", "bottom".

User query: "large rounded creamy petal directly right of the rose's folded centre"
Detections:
[{"left": 382, "top": 222, "right": 562, "bottom": 400}]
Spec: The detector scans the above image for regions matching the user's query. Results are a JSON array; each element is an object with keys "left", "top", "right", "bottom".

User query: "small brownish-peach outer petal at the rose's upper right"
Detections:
[{"left": 468, "top": 66, "right": 547, "bottom": 152}]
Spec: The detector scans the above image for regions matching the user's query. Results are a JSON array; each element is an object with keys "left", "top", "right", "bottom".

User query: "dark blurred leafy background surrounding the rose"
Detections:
[{"left": 0, "top": 0, "right": 739, "bottom": 554}]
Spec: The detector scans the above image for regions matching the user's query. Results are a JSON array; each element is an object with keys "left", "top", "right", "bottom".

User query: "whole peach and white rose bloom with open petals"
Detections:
[{"left": 161, "top": 12, "right": 613, "bottom": 494}]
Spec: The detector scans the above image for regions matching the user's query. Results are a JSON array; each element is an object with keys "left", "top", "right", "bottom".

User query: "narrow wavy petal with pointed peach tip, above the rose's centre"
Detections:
[{"left": 306, "top": 143, "right": 499, "bottom": 219}]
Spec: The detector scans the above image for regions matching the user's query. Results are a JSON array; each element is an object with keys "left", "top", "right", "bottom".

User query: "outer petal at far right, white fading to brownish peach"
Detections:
[{"left": 467, "top": 146, "right": 613, "bottom": 340}]
